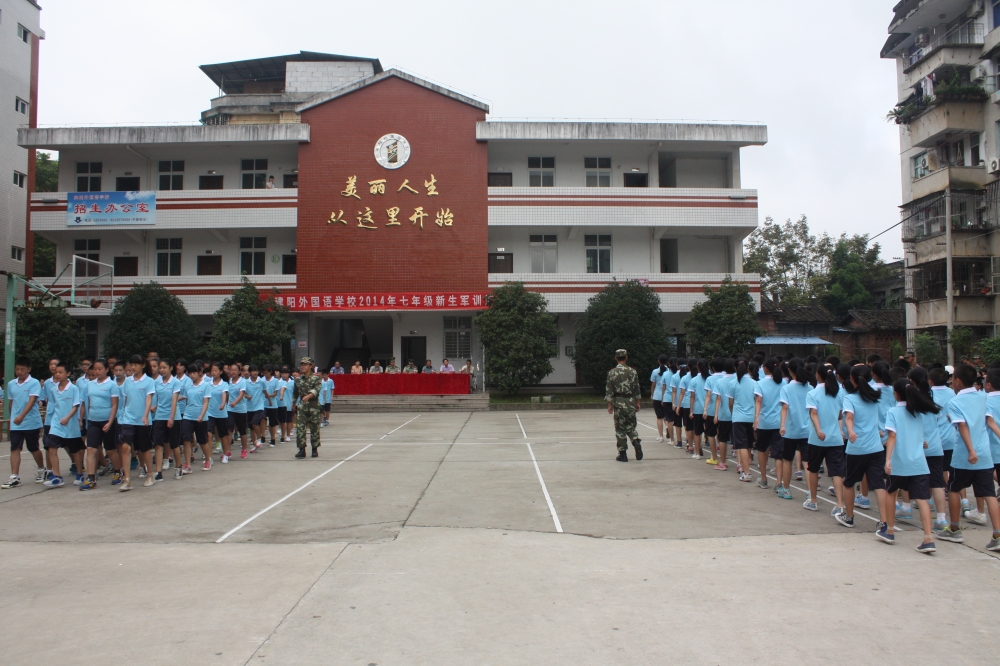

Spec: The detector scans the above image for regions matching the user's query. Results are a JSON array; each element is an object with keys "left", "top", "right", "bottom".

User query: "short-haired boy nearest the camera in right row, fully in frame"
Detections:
[{"left": 934, "top": 364, "right": 1000, "bottom": 551}]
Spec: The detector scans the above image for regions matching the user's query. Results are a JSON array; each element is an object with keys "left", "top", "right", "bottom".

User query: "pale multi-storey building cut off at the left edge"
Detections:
[{"left": 0, "top": 0, "right": 45, "bottom": 311}]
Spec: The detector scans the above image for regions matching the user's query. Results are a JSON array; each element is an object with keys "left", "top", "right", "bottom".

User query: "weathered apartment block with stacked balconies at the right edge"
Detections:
[{"left": 881, "top": 0, "right": 1000, "bottom": 358}]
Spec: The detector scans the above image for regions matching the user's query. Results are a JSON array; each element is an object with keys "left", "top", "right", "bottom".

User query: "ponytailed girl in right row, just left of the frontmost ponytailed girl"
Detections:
[{"left": 835, "top": 365, "right": 893, "bottom": 527}]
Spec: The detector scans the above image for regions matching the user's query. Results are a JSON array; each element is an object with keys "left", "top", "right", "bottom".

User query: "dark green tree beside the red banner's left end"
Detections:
[{"left": 202, "top": 276, "right": 293, "bottom": 365}]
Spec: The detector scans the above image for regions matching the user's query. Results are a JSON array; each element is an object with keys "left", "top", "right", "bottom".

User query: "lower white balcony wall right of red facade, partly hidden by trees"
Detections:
[{"left": 489, "top": 272, "right": 760, "bottom": 313}]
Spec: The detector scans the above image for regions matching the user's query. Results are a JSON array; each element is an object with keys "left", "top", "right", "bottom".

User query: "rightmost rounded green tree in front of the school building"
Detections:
[{"left": 684, "top": 275, "right": 763, "bottom": 356}]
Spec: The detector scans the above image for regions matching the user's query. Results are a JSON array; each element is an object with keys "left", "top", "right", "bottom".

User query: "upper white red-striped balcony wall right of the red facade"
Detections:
[{"left": 488, "top": 187, "right": 757, "bottom": 235}]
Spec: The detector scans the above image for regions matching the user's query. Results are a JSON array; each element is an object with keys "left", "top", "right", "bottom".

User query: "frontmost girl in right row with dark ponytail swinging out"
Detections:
[{"left": 888, "top": 379, "right": 940, "bottom": 553}]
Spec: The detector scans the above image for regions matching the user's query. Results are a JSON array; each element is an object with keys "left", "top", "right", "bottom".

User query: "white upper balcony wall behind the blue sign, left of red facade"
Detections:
[{"left": 31, "top": 188, "right": 299, "bottom": 233}]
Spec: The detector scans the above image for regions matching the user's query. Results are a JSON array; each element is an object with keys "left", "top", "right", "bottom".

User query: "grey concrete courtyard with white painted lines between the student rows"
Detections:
[{"left": 0, "top": 410, "right": 1000, "bottom": 666}]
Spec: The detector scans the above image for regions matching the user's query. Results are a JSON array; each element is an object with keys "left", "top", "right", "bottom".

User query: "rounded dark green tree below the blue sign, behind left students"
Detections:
[{"left": 104, "top": 282, "right": 201, "bottom": 359}]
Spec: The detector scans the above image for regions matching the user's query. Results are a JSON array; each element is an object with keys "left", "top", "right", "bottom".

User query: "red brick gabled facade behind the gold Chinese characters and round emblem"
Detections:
[{"left": 297, "top": 77, "right": 488, "bottom": 293}]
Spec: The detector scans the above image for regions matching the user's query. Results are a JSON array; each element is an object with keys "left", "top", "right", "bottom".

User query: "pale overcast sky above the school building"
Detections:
[{"left": 38, "top": 0, "right": 902, "bottom": 260}]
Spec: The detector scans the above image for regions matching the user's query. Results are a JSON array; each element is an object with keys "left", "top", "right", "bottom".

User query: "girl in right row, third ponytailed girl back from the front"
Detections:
[{"left": 802, "top": 364, "right": 846, "bottom": 508}]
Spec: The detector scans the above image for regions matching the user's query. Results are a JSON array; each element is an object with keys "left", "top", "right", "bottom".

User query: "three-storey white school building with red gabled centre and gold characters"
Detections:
[{"left": 20, "top": 52, "right": 767, "bottom": 384}]
